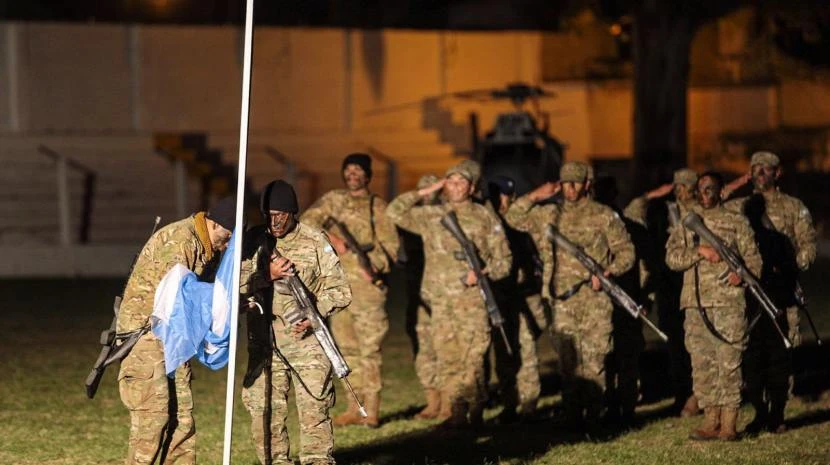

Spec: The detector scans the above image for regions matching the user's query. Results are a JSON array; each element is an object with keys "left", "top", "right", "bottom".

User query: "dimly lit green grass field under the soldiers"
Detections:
[{"left": 0, "top": 261, "right": 830, "bottom": 465}]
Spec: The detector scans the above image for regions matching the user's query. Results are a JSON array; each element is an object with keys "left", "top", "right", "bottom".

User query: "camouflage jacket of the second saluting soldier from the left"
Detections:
[{"left": 505, "top": 196, "right": 635, "bottom": 298}]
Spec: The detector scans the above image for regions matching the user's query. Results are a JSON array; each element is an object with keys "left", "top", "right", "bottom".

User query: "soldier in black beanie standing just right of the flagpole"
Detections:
[{"left": 240, "top": 180, "right": 351, "bottom": 465}]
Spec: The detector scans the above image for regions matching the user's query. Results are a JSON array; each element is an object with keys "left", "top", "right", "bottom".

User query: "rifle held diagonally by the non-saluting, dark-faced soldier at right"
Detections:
[{"left": 683, "top": 212, "right": 792, "bottom": 349}]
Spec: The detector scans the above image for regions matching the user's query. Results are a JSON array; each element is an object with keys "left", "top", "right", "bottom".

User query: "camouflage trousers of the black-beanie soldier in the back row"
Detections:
[{"left": 330, "top": 275, "right": 389, "bottom": 394}]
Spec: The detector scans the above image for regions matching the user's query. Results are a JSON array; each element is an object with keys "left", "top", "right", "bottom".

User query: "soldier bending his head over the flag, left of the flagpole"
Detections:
[{"left": 117, "top": 198, "right": 236, "bottom": 465}]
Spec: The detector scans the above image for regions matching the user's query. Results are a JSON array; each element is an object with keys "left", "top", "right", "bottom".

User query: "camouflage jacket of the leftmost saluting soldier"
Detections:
[{"left": 386, "top": 191, "right": 512, "bottom": 293}]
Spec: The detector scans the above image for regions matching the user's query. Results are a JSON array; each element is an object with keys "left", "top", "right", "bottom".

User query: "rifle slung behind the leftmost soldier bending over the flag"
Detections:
[{"left": 85, "top": 216, "right": 161, "bottom": 399}]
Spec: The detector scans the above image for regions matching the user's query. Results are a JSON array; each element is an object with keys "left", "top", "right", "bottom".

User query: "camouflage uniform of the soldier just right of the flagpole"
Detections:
[{"left": 240, "top": 223, "right": 351, "bottom": 464}]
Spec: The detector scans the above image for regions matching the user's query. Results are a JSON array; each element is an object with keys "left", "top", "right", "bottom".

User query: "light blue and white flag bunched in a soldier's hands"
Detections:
[{"left": 151, "top": 230, "right": 234, "bottom": 376}]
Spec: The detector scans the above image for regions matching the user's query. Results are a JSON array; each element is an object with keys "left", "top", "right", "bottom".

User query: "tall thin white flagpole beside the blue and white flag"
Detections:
[{"left": 222, "top": 0, "right": 254, "bottom": 465}]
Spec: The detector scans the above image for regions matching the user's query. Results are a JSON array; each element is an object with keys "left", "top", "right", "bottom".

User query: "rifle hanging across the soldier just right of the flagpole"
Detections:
[{"left": 274, "top": 247, "right": 369, "bottom": 418}]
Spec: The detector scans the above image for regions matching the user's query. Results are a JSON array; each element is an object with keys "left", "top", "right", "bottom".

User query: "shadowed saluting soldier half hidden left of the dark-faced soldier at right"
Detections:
[{"left": 623, "top": 168, "right": 700, "bottom": 418}]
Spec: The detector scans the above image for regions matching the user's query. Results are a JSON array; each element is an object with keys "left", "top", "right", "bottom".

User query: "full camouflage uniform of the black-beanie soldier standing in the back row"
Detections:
[{"left": 302, "top": 189, "right": 398, "bottom": 409}]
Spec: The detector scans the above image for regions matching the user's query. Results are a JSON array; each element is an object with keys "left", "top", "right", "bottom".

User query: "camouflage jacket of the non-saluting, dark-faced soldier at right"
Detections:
[{"left": 666, "top": 206, "right": 761, "bottom": 308}]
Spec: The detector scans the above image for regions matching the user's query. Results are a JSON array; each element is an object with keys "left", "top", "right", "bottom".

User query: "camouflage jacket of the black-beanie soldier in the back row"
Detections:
[{"left": 302, "top": 189, "right": 400, "bottom": 279}]
